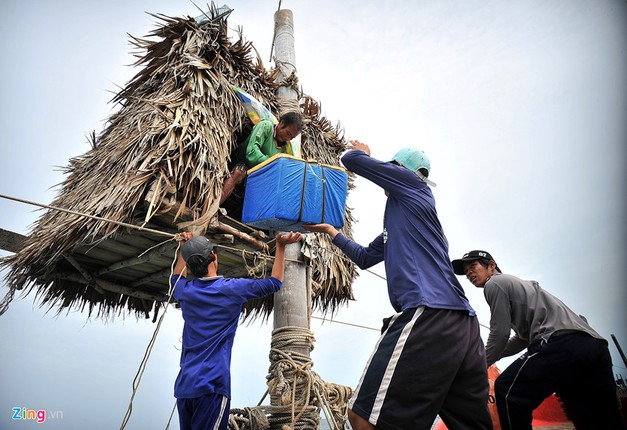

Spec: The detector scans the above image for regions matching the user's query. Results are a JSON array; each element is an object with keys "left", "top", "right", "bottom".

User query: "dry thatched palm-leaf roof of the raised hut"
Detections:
[{"left": 0, "top": 11, "right": 355, "bottom": 317}]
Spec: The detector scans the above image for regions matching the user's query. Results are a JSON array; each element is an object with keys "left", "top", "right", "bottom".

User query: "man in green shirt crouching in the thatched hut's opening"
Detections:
[{"left": 220, "top": 112, "right": 304, "bottom": 205}]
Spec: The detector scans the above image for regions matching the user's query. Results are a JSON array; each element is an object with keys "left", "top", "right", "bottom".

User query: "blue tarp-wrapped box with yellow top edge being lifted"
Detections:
[{"left": 242, "top": 154, "right": 348, "bottom": 231}]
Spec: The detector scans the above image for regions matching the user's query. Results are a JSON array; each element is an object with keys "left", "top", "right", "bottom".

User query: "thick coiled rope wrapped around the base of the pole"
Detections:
[{"left": 229, "top": 326, "right": 352, "bottom": 430}]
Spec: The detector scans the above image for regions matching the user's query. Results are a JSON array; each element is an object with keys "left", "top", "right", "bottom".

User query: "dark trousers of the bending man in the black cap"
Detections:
[{"left": 494, "top": 333, "right": 623, "bottom": 430}]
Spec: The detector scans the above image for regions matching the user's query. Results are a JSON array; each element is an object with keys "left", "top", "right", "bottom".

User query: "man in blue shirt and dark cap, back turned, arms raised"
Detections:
[{"left": 172, "top": 232, "right": 301, "bottom": 430}]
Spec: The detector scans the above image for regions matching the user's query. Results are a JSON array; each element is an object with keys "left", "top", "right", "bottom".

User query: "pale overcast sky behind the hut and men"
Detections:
[{"left": 0, "top": 0, "right": 627, "bottom": 430}]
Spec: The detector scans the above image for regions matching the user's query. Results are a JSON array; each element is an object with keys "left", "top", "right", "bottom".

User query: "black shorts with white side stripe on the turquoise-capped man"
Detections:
[{"left": 348, "top": 307, "right": 492, "bottom": 430}]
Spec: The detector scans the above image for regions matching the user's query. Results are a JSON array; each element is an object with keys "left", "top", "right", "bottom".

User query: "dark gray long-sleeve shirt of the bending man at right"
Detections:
[{"left": 483, "top": 273, "right": 603, "bottom": 366}]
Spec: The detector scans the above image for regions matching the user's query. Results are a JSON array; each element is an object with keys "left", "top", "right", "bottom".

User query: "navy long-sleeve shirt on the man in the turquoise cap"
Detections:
[{"left": 333, "top": 150, "right": 475, "bottom": 316}]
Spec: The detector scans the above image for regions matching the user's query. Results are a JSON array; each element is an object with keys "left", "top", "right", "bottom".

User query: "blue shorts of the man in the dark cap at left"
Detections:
[{"left": 176, "top": 393, "right": 231, "bottom": 430}]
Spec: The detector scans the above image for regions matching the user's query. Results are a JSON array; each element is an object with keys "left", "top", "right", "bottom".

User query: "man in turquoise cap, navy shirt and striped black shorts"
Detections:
[{"left": 306, "top": 141, "right": 492, "bottom": 430}]
